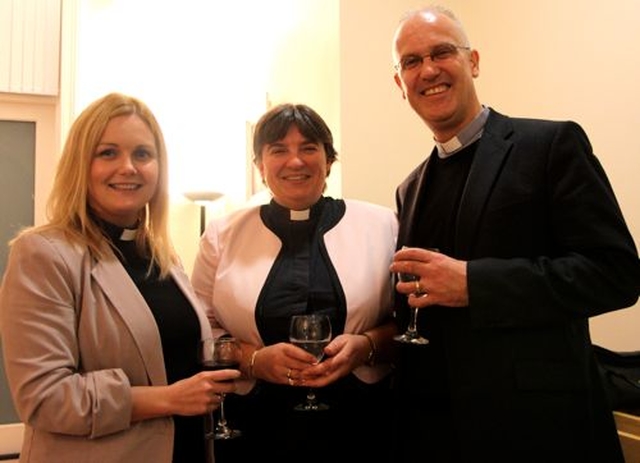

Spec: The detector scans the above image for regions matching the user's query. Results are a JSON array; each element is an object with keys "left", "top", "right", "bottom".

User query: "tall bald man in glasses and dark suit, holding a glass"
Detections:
[{"left": 390, "top": 7, "right": 640, "bottom": 463}]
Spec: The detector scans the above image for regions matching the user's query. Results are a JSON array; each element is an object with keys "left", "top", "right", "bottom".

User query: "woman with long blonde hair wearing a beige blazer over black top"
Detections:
[{"left": 0, "top": 93, "right": 239, "bottom": 463}]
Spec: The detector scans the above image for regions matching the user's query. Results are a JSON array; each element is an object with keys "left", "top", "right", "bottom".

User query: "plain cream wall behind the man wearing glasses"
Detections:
[{"left": 340, "top": 0, "right": 640, "bottom": 350}]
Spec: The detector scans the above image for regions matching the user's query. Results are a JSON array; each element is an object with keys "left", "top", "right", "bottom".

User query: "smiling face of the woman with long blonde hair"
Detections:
[{"left": 88, "top": 114, "right": 159, "bottom": 227}]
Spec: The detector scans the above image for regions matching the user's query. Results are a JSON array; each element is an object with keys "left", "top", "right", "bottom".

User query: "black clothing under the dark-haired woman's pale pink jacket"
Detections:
[{"left": 215, "top": 197, "right": 390, "bottom": 463}]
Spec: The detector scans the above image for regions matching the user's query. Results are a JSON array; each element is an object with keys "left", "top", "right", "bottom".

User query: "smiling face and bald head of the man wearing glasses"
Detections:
[{"left": 393, "top": 10, "right": 482, "bottom": 142}]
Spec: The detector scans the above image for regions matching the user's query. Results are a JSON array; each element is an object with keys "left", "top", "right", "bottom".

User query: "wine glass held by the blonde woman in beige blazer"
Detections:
[{"left": 201, "top": 336, "right": 242, "bottom": 439}]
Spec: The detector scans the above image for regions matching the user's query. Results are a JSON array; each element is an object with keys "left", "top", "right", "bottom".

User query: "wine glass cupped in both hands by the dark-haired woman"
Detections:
[{"left": 289, "top": 314, "right": 331, "bottom": 411}]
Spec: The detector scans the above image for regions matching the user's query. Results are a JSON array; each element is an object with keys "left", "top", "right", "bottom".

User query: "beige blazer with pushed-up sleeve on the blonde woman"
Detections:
[{"left": 0, "top": 231, "right": 211, "bottom": 463}]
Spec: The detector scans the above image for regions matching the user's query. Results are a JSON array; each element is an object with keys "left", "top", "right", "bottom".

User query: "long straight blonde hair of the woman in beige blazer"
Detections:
[{"left": 15, "top": 93, "right": 178, "bottom": 277}]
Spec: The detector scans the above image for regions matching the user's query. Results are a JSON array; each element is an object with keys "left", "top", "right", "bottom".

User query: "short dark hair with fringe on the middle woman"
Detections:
[{"left": 253, "top": 103, "right": 338, "bottom": 163}]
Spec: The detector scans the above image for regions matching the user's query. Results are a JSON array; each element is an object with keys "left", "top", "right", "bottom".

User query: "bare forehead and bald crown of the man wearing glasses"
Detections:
[{"left": 394, "top": 11, "right": 460, "bottom": 58}]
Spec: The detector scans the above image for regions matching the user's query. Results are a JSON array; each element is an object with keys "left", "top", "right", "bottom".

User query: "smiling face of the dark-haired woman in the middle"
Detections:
[{"left": 257, "top": 124, "right": 331, "bottom": 210}]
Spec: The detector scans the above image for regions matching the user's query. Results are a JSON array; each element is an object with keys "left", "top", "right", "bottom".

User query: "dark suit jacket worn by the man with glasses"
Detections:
[{"left": 396, "top": 110, "right": 640, "bottom": 463}]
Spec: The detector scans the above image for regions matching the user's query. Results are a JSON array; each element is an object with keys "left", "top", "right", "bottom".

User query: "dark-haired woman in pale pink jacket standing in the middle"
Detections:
[{"left": 192, "top": 104, "right": 397, "bottom": 463}]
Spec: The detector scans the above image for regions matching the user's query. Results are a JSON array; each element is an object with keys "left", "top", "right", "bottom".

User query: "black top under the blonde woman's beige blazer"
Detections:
[{"left": 100, "top": 222, "right": 205, "bottom": 463}]
